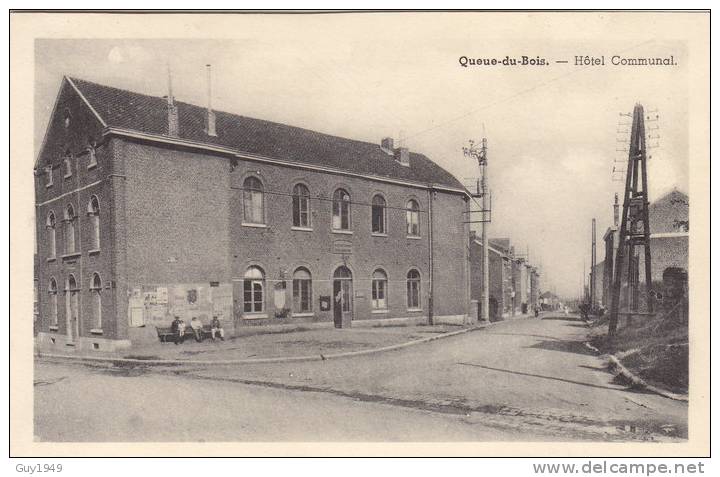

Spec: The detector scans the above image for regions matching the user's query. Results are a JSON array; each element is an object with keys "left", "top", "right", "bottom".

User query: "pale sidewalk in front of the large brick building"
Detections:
[{"left": 39, "top": 325, "right": 483, "bottom": 361}]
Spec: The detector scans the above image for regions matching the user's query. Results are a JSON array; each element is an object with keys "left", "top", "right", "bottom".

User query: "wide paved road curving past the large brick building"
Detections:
[{"left": 35, "top": 316, "right": 687, "bottom": 441}]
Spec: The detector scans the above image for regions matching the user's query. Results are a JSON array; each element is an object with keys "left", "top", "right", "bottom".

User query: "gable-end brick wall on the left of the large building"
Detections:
[{"left": 35, "top": 83, "right": 118, "bottom": 341}]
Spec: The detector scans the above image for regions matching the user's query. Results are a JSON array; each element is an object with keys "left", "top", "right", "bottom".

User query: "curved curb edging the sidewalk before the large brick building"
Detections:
[{"left": 35, "top": 323, "right": 493, "bottom": 366}]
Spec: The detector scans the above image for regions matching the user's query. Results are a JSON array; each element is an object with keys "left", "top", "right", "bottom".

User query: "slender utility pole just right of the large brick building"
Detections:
[{"left": 463, "top": 138, "right": 491, "bottom": 322}]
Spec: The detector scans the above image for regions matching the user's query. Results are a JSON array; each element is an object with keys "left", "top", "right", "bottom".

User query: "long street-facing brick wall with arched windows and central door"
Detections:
[{"left": 116, "top": 141, "right": 468, "bottom": 334}]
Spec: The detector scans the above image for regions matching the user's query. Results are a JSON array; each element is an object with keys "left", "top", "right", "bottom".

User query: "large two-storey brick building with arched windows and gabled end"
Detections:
[{"left": 35, "top": 77, "right": 469, "bottom": 350}]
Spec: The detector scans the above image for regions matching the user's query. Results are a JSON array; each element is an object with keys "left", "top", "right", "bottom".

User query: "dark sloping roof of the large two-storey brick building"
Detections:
[{"left": 66, "top": 78, "right": 465, "bottom": 191}]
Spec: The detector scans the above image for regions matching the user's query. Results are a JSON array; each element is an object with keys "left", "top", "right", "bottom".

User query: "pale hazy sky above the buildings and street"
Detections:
[{"left": 34, "top": 15, "right": 688, "bottom": 296}]
